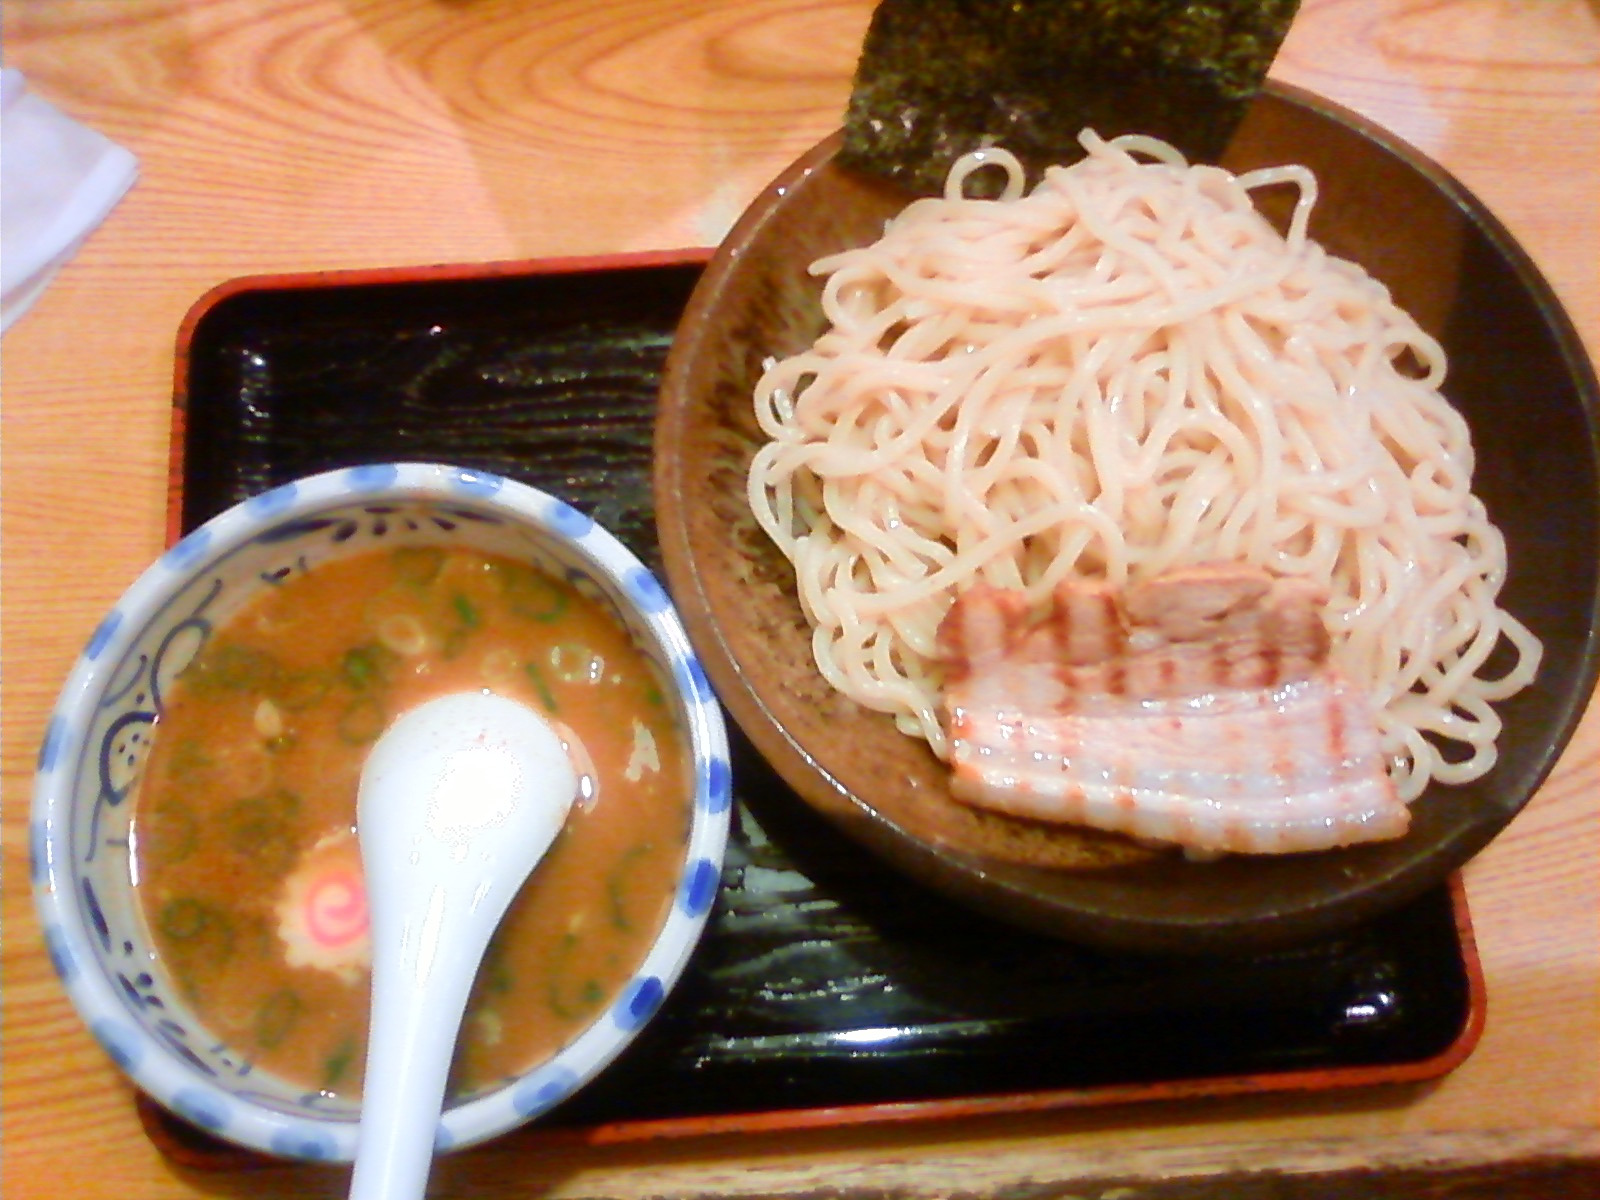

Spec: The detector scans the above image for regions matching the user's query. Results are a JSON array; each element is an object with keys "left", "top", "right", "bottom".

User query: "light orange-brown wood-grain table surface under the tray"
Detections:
[{"left": 0, "top": 0, "right": 1600, "bottom": 1200}]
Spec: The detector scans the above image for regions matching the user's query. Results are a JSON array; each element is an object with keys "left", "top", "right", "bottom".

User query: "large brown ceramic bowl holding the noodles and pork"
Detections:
[{"left": 654, "top": 86, "right": 1600, "bottom": 952}]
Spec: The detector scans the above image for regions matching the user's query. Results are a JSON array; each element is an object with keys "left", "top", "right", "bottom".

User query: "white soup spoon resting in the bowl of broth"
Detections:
[{"left": 350, "top": 693, "right": 578, "bottom": 1200}]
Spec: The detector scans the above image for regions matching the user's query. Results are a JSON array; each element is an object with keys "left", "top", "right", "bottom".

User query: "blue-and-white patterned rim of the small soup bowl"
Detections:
[{"left": 29, "top": 462, "right": 731, "bottom": 1162}]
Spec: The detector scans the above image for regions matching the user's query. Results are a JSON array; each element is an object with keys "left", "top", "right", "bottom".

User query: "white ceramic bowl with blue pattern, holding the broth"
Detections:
[{"left": 32, "top": 462, "right": 731, "bottom": 1160}]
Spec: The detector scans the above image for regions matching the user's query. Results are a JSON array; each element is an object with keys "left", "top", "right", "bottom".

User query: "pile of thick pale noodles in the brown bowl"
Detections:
[{"left": 749, "top": 133, "right": 1541, "bottom": 800}]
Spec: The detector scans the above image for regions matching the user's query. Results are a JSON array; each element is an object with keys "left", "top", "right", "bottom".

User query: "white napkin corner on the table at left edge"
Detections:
[{"left": 0, "top": 69, "right": 139, "bottom": 331}]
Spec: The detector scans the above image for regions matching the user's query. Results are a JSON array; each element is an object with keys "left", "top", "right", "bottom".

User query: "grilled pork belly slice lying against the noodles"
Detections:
[{"left": 939, "top": 565, "right": 1410, "bottom": 854}]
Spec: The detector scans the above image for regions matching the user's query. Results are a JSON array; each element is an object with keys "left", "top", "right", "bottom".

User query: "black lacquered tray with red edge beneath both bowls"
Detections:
[{"left": 146, "top": 251, "right": 1483, "bottom": 1163}]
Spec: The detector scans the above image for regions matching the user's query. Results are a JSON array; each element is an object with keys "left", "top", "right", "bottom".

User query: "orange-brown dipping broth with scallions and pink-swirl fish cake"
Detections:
[{"left": 133, "top": 547, "right": 691, "bottom": 1096}]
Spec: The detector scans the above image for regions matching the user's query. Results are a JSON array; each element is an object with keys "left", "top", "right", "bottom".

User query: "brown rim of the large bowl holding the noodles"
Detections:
[{"left": 654, "top": 80, "right": 1600, "bottom": 954}]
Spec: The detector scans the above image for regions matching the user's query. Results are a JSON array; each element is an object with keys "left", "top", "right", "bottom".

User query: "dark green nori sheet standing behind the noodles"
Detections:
[{"left": 840, "top": 0, "right": 1299, "bottom": 195}]
